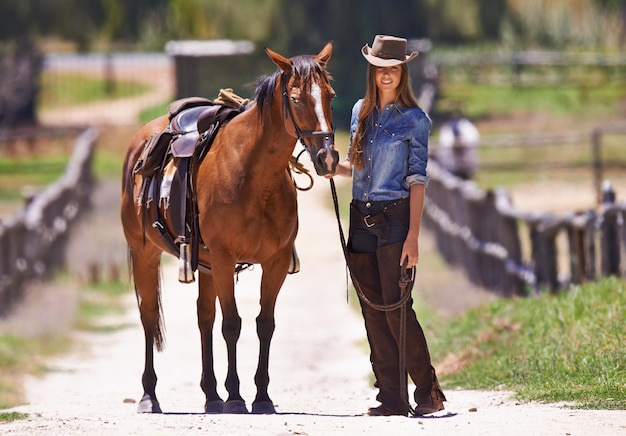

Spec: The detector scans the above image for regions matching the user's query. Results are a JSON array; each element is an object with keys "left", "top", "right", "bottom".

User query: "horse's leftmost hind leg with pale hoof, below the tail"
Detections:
[{"left": 130, "top": 245, "right": 164, "bottom": 413}]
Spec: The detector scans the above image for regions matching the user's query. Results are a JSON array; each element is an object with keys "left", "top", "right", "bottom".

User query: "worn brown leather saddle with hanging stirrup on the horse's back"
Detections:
[{"left": 133, "top": 90, "right": 249, "bottom": 283}]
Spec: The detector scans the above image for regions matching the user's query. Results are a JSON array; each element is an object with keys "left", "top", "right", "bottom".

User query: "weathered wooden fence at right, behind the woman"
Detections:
[{"left": 424, "top": 160, "right": 626, "bottom": 296}]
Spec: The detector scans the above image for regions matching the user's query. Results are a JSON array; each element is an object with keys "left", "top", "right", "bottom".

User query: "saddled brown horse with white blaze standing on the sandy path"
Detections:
[{"left": 121, "top": 43, "right": 339, "bottom": 413}]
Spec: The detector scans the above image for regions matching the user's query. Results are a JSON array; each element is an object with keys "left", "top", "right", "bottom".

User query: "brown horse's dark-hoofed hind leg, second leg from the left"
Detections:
[{"left": 197, "top": 273, "right": 224, "bottom": 413}]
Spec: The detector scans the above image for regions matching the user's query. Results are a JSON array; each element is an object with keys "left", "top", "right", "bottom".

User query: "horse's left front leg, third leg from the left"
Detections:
[{"left": 212, "top": 260, "right": 248, "bottom": 414}]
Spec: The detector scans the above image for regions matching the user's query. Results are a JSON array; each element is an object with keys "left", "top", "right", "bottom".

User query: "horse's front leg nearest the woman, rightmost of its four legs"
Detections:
[{"left": 252, "top": 255, "right": 291, "bottom": 414}]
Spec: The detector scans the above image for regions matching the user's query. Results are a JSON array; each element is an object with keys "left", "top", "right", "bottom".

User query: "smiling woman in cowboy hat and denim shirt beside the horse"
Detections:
[{"left": 337, "top": 35, "right": 445, "bottom": 416}]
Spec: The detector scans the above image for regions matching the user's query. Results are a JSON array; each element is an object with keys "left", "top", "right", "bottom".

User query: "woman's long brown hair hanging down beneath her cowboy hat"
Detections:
[{"left": 350, "top": 64, "right": 419, "bottom": 169}]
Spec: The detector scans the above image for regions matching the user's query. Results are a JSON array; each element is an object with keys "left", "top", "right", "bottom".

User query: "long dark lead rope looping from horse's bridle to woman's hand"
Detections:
[{"left": 330, "top": 178, "right": 415, "bottom": 416}]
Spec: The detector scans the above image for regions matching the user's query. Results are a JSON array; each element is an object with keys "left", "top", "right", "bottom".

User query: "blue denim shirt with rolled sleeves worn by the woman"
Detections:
[{"left": 348, "top": 100, "right": 431, "bottom": 201}]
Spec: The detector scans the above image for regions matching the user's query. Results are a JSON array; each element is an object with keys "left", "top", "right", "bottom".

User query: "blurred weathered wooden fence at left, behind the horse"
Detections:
[{"left": 0, "top": 128, "right": 98, "bottom": 315}]
